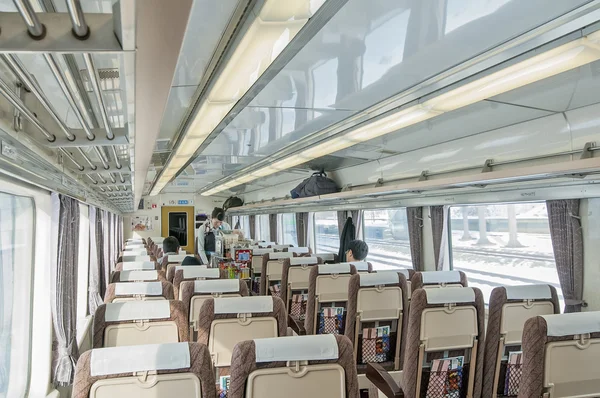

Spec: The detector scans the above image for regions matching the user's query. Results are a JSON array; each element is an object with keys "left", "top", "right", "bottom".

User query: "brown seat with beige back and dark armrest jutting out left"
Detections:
[{"left": 367, "top": 287, "right": 485, "bottom": 398}]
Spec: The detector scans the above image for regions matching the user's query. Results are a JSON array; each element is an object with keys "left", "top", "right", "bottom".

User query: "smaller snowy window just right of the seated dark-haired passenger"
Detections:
[{"left": 363, "top": 208, "right": 412, "bottom": 269}]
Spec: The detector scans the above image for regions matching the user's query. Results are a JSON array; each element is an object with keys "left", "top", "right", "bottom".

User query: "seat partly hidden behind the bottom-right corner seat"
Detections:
[{"left": 483, "top": 285, "right": 560, "bottom": 397}]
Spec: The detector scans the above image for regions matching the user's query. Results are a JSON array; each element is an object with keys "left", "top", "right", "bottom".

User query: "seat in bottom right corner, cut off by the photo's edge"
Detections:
[{"left": 518, "top": 311, "right": 600, "bottom": 398}]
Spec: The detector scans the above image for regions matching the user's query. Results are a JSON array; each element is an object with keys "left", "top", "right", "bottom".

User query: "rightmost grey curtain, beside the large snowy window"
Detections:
[{"left": 546, "top": 199, "right": 583, "bottom": 312}]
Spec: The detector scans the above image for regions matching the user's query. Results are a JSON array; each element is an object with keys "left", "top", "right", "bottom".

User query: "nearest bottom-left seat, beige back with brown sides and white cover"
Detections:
[{"left": 71, "top": 343, "right": 216, "bottom": 398}]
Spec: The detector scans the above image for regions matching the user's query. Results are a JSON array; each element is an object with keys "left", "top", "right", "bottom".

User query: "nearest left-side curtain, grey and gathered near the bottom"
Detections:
[{"left": 52, "top": 193, "right": 79, "bottom": 386}]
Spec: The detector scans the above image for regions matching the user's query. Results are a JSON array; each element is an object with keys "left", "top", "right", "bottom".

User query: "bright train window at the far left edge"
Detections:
[{"left": 0, "top": 193, "right": 35, "bottom": 397}]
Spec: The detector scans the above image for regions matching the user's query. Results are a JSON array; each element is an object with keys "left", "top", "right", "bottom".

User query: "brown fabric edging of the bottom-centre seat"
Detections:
[{"left": 227, "top": 336, "right": 360, "bottom": 398}]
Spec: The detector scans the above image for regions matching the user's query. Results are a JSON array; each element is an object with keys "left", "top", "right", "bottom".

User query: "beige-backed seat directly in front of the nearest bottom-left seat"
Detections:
[{"left": 93, "top": 300, "right": 188, "bottom": 348}]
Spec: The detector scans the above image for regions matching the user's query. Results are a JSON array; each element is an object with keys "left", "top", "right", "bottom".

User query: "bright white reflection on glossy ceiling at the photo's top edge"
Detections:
[{"left": 445, "top": 0, "right": 511, "bottom": 34}]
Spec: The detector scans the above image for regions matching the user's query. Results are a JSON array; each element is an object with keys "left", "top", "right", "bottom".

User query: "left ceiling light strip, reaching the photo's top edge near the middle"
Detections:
[{"left": 150, "top": 0, "right": 325, "bottom": 196}]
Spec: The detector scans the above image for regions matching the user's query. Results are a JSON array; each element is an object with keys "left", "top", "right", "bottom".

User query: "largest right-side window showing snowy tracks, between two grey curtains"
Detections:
[{"left": 450, "top": 202, "right": 563, "bottom": 307}]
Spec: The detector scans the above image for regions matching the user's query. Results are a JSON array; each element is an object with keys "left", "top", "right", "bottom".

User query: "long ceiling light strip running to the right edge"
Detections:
[{"left": 201, "top": 31, "right": 600, "bottom": 196}]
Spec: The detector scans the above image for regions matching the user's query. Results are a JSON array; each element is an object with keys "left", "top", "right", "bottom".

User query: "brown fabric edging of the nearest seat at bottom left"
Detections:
[{"left": 71, "top": 343, "right": 217, "bottom": 398}]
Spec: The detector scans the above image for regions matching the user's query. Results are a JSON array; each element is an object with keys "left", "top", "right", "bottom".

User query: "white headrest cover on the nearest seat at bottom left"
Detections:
[{"left": 90, "top": 343, "right": 190, "bottom": 377}]
